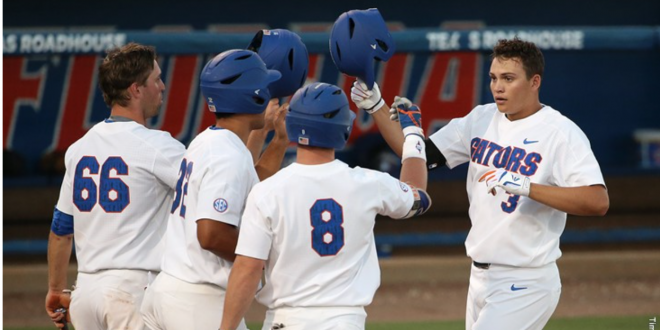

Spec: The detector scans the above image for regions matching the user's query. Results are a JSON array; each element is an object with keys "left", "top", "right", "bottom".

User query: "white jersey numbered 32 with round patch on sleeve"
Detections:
[{"left": 163, "top": 127, "right": 259, "bottom": 288}]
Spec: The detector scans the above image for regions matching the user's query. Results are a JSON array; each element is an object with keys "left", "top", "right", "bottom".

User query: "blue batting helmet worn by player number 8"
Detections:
[{"left": 286, "top": 83, "right": 355, "bottom": 149}]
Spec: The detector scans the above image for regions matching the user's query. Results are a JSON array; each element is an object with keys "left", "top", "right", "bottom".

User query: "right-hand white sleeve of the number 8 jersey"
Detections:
[{"left": 378, "top": 173, "right": 415, "bottom": 219}]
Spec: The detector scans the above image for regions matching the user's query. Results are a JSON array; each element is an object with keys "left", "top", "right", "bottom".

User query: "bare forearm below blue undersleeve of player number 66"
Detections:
[{"left": 48, "top": 231, "right": 73, "bottom": 293}]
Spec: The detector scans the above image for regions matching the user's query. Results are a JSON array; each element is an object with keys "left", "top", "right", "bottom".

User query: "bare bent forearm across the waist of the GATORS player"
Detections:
[{"left": 529, "top": 183, "right": 610, "bottom": 216}]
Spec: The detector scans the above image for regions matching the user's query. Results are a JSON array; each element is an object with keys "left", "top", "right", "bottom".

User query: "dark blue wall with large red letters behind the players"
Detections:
[{"left": 3, "top": 27, "right": 660, "bottom": 186}]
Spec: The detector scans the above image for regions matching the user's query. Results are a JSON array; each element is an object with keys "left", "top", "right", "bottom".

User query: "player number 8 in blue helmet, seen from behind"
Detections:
[{"left": 220, "top": 83, "right": 431, "bottom": 330}]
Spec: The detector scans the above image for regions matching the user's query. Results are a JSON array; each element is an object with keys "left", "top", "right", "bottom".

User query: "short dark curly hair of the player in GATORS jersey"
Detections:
[{"left": 490, "top": 37, "right": 545, "bottom": 79}]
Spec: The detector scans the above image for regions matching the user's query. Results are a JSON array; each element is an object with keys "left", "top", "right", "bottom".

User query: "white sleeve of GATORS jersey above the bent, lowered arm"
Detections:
[{"left": 553, "top": 126, "right": 605, "bottom": 187}]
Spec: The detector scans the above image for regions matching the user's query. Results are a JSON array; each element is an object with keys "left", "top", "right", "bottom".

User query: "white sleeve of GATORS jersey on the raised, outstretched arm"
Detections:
[{"left": 429, "top": 109, "right": 476, "bottom": 169}]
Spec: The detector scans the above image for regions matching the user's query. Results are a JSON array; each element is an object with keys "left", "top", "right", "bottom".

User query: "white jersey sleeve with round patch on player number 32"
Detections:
[{"left": 193, "top": 155, "right": 251, "bottom": 226}]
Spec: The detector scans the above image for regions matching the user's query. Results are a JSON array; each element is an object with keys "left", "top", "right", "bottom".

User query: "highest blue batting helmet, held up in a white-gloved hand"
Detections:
[{"left": 330, "top": 8, "right": 394, "bottom": 89}]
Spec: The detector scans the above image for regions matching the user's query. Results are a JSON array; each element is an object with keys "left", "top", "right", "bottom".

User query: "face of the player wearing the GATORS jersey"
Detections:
[{"left": 490, "top": 58, "right": 540, "bottom": 120}]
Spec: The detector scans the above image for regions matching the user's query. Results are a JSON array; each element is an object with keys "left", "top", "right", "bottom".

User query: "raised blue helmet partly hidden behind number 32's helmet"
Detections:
[{"left": 247, "top": 29, "right": 309, "bottom": 97}]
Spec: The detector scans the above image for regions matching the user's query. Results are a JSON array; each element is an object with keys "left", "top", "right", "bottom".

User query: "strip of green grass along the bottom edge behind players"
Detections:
[{"left": 4, "top": 316, "right": 649, "bottom": 330}]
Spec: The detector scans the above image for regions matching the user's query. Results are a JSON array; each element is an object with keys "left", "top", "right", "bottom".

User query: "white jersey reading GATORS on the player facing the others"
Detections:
[{"left": 430, "top": 103, "right": 604, "bottom": 267}]
